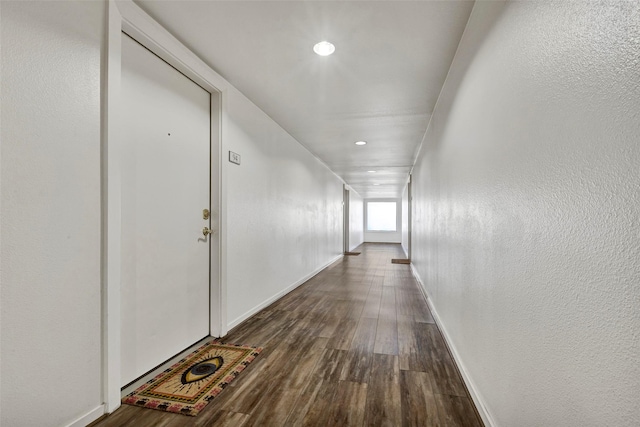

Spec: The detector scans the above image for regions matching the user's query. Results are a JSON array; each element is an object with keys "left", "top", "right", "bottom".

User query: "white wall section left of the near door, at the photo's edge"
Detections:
[{"left": 0, "top": 1, "right": 105, "bottom": 427}]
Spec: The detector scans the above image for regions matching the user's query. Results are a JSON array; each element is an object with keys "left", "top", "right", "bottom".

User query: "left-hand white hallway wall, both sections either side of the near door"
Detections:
[{"left": 0, "top": 1, "right": 342, "bottom": 426}]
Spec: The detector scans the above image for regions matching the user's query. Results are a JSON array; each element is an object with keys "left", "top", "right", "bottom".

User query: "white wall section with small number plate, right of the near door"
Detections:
[{"left": 222, "top": 88, "right": 343, "bottom": 325}]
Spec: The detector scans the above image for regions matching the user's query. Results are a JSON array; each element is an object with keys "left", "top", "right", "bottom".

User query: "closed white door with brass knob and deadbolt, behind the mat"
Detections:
[{"left": 121, "top": 33, "right": 211, "bottom": 385}]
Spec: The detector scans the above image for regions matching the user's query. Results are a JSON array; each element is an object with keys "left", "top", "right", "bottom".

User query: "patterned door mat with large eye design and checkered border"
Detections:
[{"left": 122, "top": 341, "right": 262, "bottom": 416}]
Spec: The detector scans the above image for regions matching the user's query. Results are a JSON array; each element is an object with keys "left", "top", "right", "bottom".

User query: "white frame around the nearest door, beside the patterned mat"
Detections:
[{"left": 101, "top": 0, "right": 227, "bottom": 413}]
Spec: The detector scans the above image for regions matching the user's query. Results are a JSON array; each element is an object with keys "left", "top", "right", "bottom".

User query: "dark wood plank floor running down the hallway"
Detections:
[{"left": 95, "top": 244, "right": 482, "bottom": 427}]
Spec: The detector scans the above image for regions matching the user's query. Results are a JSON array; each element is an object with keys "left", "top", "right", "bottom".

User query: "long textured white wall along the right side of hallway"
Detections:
[{"left": 413, "top": 1, "right": 640, "bottom": 427}]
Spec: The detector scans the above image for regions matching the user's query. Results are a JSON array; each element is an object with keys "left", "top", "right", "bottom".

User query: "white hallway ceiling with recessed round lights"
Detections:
[{"left": 136, "top": 0, "right": 473, "bottom": 198}]
